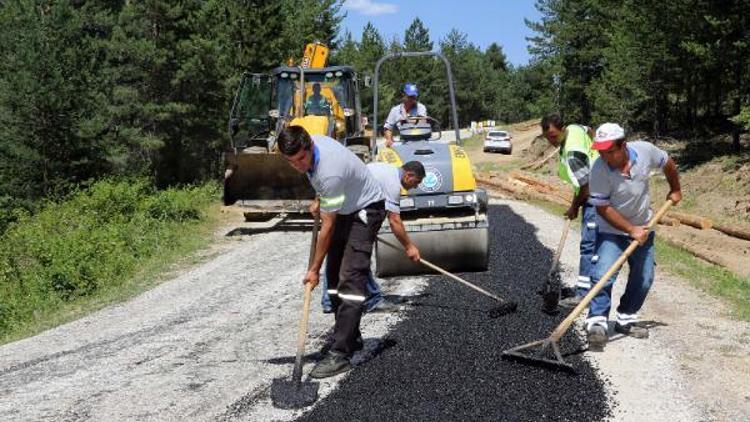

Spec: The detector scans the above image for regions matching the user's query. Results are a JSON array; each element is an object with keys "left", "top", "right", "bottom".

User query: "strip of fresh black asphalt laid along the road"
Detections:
[{"left": 300, "top": 205, "right": 613, "bottom": 422}]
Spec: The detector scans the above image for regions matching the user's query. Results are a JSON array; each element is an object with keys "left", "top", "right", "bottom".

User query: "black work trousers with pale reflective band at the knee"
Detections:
[{"left": 326, "top": 201, "right": 385, "bottom": 357}]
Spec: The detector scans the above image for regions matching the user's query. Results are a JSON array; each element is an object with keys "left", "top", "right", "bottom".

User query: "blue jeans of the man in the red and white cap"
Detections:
[{"left": 586, "top": 232, "right": 654, "bottom": 329}]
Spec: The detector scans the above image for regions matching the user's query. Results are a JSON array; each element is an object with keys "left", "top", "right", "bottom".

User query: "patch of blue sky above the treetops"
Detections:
[{"left": 343, "top": 0, "right": 539, "bottom": 65}]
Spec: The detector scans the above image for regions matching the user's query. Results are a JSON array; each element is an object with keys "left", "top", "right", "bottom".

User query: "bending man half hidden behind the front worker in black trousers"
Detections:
[{"left": 321, "top": 161, "right": 425, "bottom": 313}]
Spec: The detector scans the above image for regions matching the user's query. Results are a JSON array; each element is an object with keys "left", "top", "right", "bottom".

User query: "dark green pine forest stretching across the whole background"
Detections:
[{"left": 0, "top": 0, "right": 750, "bottom": 232}]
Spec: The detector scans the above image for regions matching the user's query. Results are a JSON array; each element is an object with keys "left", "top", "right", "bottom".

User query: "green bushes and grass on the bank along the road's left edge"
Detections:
[{"left": 0, "top": 180, "right": 225, "bottom": 344}]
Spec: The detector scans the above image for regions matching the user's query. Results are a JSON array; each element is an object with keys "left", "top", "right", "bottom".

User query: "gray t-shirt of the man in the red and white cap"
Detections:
[{"left": 589, "top": 141, "right": 669, "bottom": 235}]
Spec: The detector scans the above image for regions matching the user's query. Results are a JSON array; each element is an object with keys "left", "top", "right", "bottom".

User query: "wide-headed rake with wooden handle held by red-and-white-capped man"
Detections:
[{"left": 502, "top": 200, "right": 673, "bottom": 373}]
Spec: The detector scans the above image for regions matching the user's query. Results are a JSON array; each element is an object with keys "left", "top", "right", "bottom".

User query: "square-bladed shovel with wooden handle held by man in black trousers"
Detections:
[{"left": 271, "top": 215, "right": 320, "bottom": 409}]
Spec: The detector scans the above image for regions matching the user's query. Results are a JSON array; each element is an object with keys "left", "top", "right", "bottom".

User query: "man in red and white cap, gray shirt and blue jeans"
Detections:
[{"left": 586, "top": 123, "right": 682, "bottom": 350}]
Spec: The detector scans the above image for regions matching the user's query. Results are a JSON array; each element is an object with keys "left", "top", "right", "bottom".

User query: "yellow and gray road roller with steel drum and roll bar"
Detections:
[{"left": 373, "top": 52, "right": 489, "bottom": 277}]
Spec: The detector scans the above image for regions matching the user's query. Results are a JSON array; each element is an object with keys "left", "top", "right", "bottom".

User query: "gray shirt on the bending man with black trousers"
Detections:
[{"left": 307, "top": 135, "right": 384, "bottom": 215}]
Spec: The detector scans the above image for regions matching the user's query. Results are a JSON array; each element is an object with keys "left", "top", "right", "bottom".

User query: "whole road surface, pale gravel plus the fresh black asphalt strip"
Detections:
[{"left": 0, "top": 200, "right": 732, "bottom": 421}]
